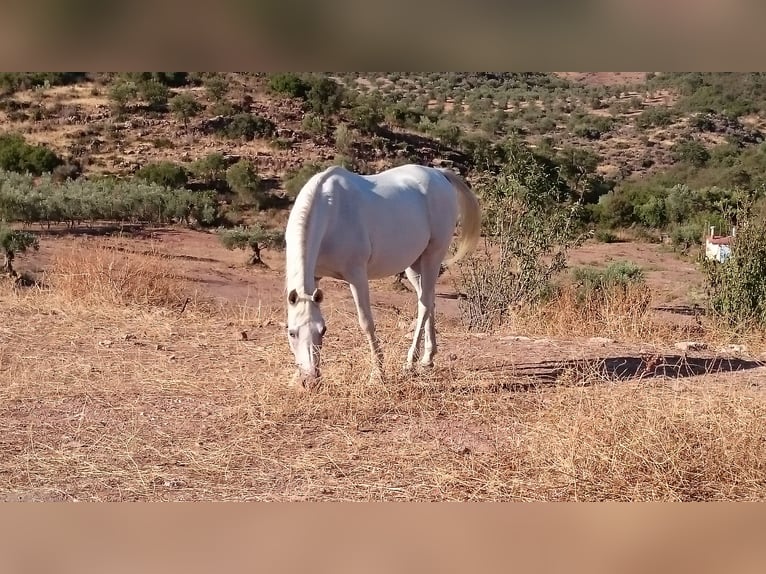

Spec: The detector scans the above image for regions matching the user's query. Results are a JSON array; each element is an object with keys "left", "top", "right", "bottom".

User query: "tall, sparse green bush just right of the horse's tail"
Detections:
[{"left": 456, "top": 139, "right": 584, "bottom": 331}]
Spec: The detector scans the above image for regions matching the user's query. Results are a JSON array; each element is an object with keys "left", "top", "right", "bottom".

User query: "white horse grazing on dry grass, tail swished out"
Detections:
[{"left": 285, "top": 164, "right": 481, "bottom": 387}]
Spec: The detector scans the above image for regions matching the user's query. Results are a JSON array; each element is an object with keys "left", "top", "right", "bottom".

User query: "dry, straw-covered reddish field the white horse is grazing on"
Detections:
[{"left": 0, "top": 229, "right": 766, "bottom": 501}]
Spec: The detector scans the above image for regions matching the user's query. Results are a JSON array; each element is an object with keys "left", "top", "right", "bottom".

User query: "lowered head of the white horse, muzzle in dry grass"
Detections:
[{"left": 287, "top": 289, "right": 327, "bottom": 387}]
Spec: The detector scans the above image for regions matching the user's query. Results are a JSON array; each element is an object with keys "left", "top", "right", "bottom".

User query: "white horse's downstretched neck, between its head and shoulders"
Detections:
[{"left": 285, "top": 189, "right": 327, "bottom": 295}]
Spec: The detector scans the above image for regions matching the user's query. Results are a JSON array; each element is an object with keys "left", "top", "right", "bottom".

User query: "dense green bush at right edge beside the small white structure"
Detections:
[{"left": 703, "top": 217, "right": 766, "bottom": 332}]
